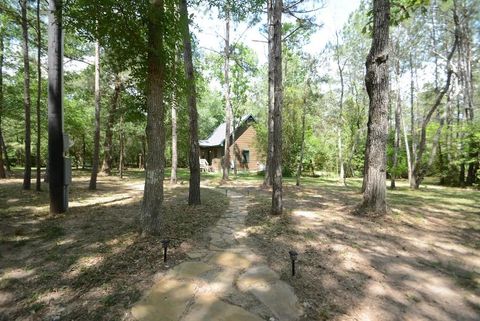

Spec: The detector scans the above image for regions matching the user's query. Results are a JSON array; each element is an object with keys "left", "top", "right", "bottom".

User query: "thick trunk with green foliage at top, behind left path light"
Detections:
[{"left": 140, "top": 0, "right": 165, "bottom": 235}]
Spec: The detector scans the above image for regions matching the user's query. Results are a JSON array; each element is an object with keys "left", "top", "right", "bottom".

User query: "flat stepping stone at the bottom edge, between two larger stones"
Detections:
[{"left": 183, "top": 294, "right": 264, "bottom": 321}]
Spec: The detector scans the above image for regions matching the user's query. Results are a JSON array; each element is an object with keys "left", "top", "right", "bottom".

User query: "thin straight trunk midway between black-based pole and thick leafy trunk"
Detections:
[{"left": 88, "top": 40, "right": 100, "bottom": 190}]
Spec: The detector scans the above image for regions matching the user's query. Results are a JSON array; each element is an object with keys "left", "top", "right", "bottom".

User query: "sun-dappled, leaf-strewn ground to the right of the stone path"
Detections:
[{"left": 243, "top": 181, "right": 480, "bottom": 321}]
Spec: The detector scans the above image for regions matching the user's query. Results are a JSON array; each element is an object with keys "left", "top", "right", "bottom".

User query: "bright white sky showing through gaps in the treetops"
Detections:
[{"left": 192, "top": 0, "right": 360, "bottom": 64}]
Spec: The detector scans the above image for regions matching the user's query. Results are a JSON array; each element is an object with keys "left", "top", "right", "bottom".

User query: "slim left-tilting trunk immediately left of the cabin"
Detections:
[{"left": 180, "top": 0, "right": 201, "bottom": 205}]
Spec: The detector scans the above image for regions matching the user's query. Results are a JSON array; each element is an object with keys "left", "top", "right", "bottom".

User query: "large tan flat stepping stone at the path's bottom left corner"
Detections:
[{"left": 132, "top": 279, "right": 196, "bottom": 321}]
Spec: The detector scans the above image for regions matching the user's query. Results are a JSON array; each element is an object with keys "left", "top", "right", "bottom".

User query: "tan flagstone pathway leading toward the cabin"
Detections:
[{"left": 132, "top": 191, "right": 302, "bottom": 321}]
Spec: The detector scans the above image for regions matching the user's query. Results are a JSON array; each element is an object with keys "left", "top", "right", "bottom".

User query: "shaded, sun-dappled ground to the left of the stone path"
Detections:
[{"left": 0, "top": 177, "right": 228, "bottom": 321}]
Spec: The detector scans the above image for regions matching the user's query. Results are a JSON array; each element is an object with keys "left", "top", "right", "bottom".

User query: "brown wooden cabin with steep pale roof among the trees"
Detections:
[{"left": 199, "top": 115, "right": 264, "bottom": 171}]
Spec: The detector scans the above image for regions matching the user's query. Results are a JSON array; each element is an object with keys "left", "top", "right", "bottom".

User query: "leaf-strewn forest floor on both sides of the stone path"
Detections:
[{"left": 0, "top": 172, "right": 480, "bottom": 321}]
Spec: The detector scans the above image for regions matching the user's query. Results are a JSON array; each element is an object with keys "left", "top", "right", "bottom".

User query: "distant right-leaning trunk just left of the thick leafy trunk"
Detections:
[{"left": 102, "top": 74, "right": 123, "bottom": 175}]
